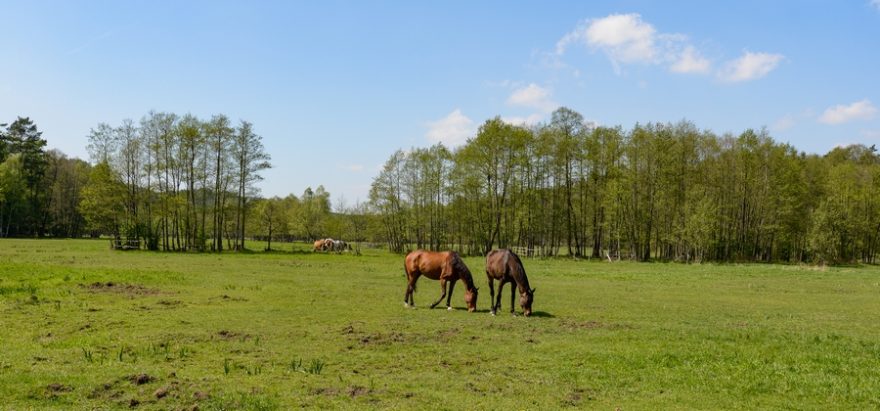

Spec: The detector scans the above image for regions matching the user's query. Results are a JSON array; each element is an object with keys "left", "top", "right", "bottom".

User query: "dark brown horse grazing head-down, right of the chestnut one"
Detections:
[{"left": 486, "top": 249, "right": 535, "bottom": 317}]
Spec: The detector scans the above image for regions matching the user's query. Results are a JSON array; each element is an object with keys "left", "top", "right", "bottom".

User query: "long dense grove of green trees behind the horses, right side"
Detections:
[{"left": 370, "top": 108, "right": 880, "bottom": 263}]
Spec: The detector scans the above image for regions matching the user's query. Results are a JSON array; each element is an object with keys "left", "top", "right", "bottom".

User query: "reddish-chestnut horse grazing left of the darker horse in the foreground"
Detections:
[{"left": 403, "top": 250, "right": 477, "bottom": 312}]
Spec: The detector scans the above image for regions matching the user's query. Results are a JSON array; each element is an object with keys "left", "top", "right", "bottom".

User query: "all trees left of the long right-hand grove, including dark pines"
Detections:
[{"left": 0, "top": 112, "right": 368, "bottom": 251}]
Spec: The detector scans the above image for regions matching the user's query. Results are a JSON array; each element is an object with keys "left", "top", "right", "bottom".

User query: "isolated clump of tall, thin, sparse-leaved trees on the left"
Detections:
[{"left": 80, "top": 112, "right": 271, "bottom": 251}]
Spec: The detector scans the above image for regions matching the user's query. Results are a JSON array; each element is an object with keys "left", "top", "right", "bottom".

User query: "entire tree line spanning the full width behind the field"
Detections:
[{"left": 0, "top": 108, "right": 880, "bottom": 263}]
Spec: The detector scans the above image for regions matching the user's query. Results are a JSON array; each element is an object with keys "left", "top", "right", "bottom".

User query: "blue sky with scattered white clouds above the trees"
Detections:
[{"left": 0, "top": 0, "right": 880, "bottom": 204}]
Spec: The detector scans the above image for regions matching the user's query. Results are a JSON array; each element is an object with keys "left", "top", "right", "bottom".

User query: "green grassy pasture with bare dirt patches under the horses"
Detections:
[{"left": 0, "top": 240, "right": 880, "bottom": 410}]
